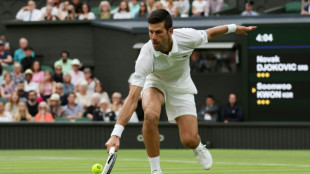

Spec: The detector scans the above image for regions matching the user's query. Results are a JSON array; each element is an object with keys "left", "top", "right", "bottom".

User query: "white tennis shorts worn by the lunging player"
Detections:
[{"left": 141, "top": 81, "right": 197, "bottom": 123}]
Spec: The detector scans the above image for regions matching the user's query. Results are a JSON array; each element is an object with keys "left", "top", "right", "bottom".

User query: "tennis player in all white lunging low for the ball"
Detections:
[{"left": 106, "top": 9, "right": 256, "bottom": 174}]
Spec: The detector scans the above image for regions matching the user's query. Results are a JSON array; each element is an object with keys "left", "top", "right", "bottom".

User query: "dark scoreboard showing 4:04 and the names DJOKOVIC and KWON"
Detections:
[{"left": 246, "top": 23, "right": 310, "bottom": 121}]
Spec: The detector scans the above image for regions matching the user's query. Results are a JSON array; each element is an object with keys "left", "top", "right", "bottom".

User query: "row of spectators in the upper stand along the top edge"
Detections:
[{"left": 16, "top": 0, "right": 266, "bottom": 21}]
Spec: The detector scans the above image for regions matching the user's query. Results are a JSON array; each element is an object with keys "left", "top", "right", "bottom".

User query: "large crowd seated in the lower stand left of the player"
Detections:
[{"left": 0, "top": 36, "right": 143, "bottom": 122}]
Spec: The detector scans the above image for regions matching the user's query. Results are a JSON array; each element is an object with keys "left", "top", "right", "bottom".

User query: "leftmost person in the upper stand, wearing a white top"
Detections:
[{"left": 16, "top": 0, "right": 42, "bottom": 21}]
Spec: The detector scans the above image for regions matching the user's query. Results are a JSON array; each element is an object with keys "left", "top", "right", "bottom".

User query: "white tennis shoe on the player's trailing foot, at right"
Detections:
[{"left": 193, "top": 145, "right": 213, "bottom": 170}]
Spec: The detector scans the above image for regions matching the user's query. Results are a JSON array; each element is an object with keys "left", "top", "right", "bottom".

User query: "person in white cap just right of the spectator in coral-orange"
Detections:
[{"left": 49, "top": 93, "right": 65, "bottom": 118}]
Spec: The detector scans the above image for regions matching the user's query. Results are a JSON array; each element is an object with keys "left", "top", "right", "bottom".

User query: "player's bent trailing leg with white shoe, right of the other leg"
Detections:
[{"left": 175, "top": 115, "right": 213, "bottom": 169}]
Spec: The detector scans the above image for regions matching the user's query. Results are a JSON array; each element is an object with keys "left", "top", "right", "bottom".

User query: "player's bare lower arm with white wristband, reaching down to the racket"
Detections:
[{"left": 105, "top": 85, "right": 142, "bottom": 152}]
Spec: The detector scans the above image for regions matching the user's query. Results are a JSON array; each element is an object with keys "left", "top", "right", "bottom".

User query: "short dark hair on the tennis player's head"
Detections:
[{"left": 147, "top": 9, "right": 172, "bottom": 30}]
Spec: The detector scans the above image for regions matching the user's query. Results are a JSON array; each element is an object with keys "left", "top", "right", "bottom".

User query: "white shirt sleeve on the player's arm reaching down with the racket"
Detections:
[{"left": 131, "top": 42, "right": 154, "bottom": 87}]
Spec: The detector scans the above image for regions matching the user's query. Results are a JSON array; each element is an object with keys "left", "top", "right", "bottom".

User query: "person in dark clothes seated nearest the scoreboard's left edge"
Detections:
[{"left": 222, "top": 93, "right": 243, "bottom": 123}]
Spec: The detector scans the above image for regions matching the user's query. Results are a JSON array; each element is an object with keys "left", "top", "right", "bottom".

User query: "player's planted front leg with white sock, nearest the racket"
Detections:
[{"left": 142, "top": 88, "right": 165, "bottom": 173}]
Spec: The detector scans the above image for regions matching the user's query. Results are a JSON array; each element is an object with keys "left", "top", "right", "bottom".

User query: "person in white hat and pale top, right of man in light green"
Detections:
[{"left": 69, "top": 59, "right": 85, "bottom": 86}]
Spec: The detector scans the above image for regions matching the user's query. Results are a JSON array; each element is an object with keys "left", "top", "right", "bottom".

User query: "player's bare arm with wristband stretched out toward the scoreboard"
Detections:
[{"left": 206, "top": 24, "right": 257, "bottom": 40}]
